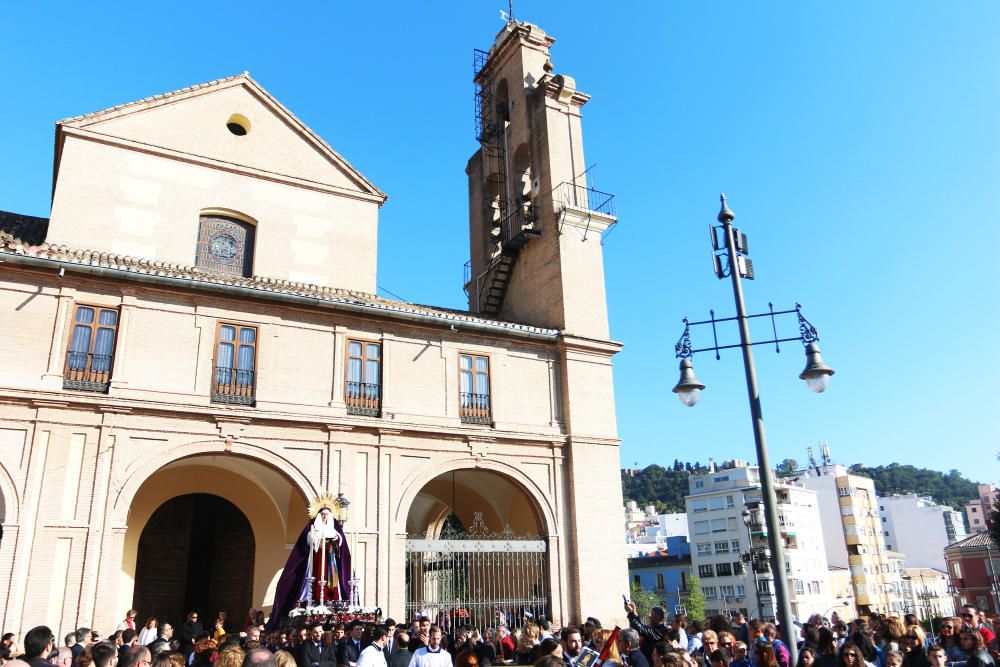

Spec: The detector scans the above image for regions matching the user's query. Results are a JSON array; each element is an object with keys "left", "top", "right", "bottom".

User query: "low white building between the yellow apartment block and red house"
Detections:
[{"left": 878, "top": 493, "right": 966, "bottom": 570}]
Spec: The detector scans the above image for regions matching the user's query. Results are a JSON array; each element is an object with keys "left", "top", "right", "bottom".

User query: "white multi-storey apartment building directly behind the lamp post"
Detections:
[{"left": 685, "top": 461, "right": 835, "bottom": 621}]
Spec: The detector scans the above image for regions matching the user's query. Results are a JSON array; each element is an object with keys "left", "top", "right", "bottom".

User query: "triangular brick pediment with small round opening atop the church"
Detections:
[{"left": 57, "top": 73, "right": 385, "bottom": 200}]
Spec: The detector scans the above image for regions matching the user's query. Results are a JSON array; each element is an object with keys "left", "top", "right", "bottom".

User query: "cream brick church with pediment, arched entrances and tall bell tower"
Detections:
[{"left": 0, "top": 22, "right": 627, "bottom": 637}]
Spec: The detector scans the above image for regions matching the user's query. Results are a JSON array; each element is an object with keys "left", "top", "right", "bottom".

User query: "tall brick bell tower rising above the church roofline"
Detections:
[{"left": 465, "top": 21, "right": 617, "bottom": 340}]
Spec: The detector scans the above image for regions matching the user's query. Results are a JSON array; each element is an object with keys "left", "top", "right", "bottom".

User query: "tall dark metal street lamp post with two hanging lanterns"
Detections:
[{"left": 674, "top": 195, "right": 834, "bottom": 665}]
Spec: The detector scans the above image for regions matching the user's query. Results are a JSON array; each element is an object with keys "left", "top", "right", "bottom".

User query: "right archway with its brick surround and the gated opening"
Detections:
[{"left": 389, "top": 455, "right": 564, "bottom": 624}]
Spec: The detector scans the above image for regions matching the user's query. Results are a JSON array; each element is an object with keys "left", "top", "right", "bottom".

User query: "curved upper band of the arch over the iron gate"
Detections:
[{"left": 393, "top": 457, "right": 558, "bottom": 537}]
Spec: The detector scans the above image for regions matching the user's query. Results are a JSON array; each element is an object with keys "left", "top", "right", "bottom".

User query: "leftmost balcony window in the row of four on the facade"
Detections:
[{"left": 63, "top": 305, "right": 118, "bottom": 393}]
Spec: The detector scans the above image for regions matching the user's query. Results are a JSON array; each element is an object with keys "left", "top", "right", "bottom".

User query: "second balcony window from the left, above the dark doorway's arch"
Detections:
[{"left": 212, "top": 322, "right": 257, "bottom": 405}]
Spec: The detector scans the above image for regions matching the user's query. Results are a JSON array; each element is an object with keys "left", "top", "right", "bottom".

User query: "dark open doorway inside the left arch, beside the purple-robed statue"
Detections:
[{"left": 132, "top": 493, "right": 255, "bottom": 627}]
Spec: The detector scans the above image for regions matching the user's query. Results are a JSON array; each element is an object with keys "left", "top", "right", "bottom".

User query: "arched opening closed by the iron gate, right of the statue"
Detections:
[{"left": 405, "top": 469, "right": 552, "bottom": 627}]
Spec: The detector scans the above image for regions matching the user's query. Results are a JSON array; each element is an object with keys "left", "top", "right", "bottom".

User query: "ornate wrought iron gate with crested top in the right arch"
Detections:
[{"left": 406, "top": 512, "right": 551, "bottom": 628}]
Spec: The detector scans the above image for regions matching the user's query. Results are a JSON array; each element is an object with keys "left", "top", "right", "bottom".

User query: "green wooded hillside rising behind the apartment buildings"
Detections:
[{"left": 622, "top": 460, "right": 977, "bottom": 512}]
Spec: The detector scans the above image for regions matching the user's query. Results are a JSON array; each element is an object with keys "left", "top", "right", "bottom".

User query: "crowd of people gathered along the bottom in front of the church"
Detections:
[{"left": 0, "top": 602, "right": 1000, "bottom": 667}]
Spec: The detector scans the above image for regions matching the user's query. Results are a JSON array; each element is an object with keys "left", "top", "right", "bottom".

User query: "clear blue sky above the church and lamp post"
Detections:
[{"left": 0, "top": 0, "right": 1000, "bottom": 482}]
